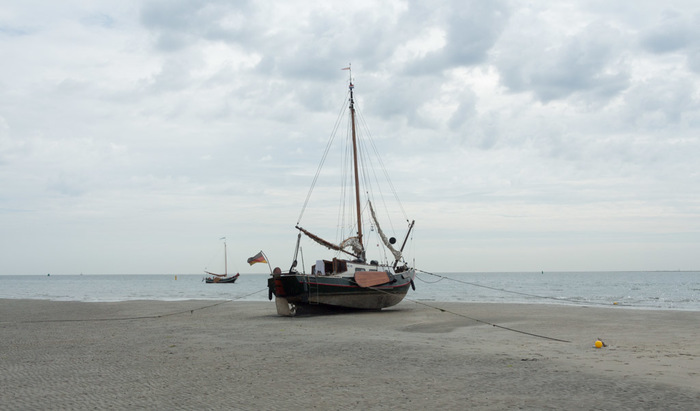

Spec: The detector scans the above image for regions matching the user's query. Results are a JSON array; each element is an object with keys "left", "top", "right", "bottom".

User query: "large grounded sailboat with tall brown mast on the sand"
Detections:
[{"left": 268, "top": 67, "right": 415, "bottom": 316}]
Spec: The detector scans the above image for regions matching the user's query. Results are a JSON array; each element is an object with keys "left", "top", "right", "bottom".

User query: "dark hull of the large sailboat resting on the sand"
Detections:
[{"left": 267, "top": 270, "right": 415, "bottom": 314}]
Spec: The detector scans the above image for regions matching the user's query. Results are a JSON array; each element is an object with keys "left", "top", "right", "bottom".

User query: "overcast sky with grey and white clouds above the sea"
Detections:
[{"left": 0, "top": 0, "right": 700, "bottom": 275}]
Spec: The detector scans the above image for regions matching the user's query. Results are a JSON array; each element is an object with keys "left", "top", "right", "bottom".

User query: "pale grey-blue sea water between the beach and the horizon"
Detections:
[{"left": 0, "top": 271, "right": 700, "bottom": 311}]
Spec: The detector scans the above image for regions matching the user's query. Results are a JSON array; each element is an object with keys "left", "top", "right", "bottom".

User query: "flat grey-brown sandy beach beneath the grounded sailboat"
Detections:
[{"left": 0, "top": 300, "right": 700, "bottom": 410}]
